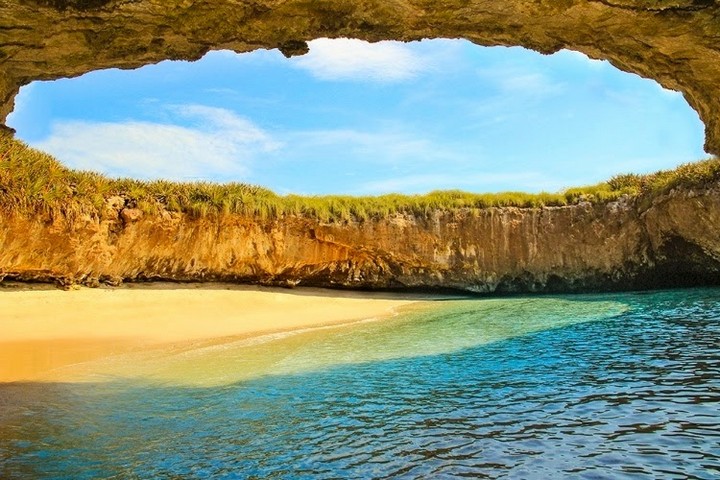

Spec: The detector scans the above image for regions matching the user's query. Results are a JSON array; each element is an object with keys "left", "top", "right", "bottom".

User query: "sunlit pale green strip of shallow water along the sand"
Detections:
[{"left": 54, "top": 297, "right": 628, "bottom": 386}]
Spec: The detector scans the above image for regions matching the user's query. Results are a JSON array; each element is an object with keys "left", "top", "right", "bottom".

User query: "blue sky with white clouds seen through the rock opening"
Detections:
[{"left": 8, "top": 39, "right": 706, "bottom": 195}]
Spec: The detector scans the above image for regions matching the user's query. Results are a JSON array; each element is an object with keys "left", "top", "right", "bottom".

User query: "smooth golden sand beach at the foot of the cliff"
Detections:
[{"left": 0, "top": 283, "right": 418, "bottom": 382}]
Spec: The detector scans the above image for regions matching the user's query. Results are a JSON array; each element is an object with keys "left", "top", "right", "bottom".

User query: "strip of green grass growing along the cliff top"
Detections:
[{"left": 0, "top": 134, "right": 720, "bottom": 221}]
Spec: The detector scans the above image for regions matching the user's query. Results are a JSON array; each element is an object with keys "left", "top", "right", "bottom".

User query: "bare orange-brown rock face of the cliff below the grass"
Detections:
[{"left": 0, "top": 184, "right": 720, "bottom": 292}]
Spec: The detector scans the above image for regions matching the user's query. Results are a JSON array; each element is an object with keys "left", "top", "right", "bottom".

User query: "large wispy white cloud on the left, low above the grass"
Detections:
[{"left": 35, "top": 105, "right": 279, "bottom": 180}]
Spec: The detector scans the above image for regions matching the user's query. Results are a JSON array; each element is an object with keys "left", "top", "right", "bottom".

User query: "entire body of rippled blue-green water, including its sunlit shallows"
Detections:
[{"left": 0, "top": 289, "right": 720, "bottom": 479}]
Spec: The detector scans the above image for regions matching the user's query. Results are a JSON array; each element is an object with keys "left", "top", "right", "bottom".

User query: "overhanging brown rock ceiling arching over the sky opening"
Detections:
[{"left": 0, "top": 0, "right": 720, "bottom": 154}]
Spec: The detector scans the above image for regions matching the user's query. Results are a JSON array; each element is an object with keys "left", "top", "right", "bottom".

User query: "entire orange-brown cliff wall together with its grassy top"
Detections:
[{"left": 0, "top": 136, "right": 720, "bottom": 292}]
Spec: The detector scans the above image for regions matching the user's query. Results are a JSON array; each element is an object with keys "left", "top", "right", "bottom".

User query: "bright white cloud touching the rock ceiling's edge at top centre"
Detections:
[{"left": 291, "top": 38, "right": 429, "bottom": 83}]
